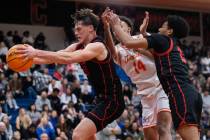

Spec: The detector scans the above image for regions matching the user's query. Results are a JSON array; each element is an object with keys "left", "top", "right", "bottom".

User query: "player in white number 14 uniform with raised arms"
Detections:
[{"left": 102, "top": 9, "right": 172, "bottom": 140}]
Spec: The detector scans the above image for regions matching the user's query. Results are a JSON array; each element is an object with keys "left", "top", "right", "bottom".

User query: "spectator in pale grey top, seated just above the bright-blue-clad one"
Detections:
[{"left": 35, "top": 89, "right": 52, "bottom": 112}]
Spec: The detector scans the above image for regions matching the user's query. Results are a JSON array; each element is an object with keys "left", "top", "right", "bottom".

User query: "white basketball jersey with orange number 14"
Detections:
[{"left": 115, "top": 44, "right": 162, "bottom": 95}]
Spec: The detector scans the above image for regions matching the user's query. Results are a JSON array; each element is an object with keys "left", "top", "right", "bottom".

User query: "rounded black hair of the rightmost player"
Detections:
[{"left": 167, "top": 15, "right": 190, "bottom": 39}]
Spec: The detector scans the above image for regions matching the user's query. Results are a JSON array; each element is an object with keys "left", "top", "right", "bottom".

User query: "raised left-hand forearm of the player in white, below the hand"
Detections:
[{"left": 104, "top": 27, "right": 118, "bottom": 60}]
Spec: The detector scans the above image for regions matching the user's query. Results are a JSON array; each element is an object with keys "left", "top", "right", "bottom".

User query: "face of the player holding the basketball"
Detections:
[{"left": 74, "top": 21, "right": 92, "bottom": 43}]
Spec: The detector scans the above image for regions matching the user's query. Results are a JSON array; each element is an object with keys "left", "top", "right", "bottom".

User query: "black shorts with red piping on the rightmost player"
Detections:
[{"left": 169, "top": 85, "right": 203, "bottom": 130}]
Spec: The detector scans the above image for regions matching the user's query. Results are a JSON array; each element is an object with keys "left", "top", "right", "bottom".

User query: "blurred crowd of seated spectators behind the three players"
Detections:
[{"left": 0, "top": 26, "right": 210, "bottom": 140}]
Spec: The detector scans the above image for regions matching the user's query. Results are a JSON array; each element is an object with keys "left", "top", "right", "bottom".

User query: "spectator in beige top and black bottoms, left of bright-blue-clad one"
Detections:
[{"left": 16, "top": 108, "right": 32, "bottom": 139}]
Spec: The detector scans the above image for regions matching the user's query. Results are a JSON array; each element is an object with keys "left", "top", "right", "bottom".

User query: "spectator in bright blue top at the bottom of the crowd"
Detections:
[{"left": 36, "top": 114, "right": 55, "bottom": 140}]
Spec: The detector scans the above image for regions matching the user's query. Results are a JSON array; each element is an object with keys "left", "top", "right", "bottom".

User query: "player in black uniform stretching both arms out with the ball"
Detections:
[{"left": 17, "top": 9, "right": 125, "bottom": 140}]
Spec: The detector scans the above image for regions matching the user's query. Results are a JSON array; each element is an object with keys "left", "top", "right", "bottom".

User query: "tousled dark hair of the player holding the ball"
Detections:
[{"left": 71, "top": 8, "right": 99, "bottom": 30}]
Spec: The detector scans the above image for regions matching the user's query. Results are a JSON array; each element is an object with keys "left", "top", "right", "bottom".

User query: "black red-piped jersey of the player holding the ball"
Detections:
[{"left": 77, "top": 37, "right": 122, "bottom": 98}]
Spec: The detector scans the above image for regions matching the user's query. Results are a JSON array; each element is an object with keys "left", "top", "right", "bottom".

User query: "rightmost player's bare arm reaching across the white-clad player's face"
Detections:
[{"left": 109, "top": 13, "right": 148, "bottom": 49}]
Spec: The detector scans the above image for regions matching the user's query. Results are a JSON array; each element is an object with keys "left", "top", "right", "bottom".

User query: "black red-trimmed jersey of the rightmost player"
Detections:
[{"left": 147, "top": 34, "right": 191, "bottom": 93}]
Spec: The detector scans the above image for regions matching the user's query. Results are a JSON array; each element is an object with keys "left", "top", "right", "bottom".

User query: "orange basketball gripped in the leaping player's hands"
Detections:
[{"left": 6, "top": 44, "right": 33, "bottom": 72}]
